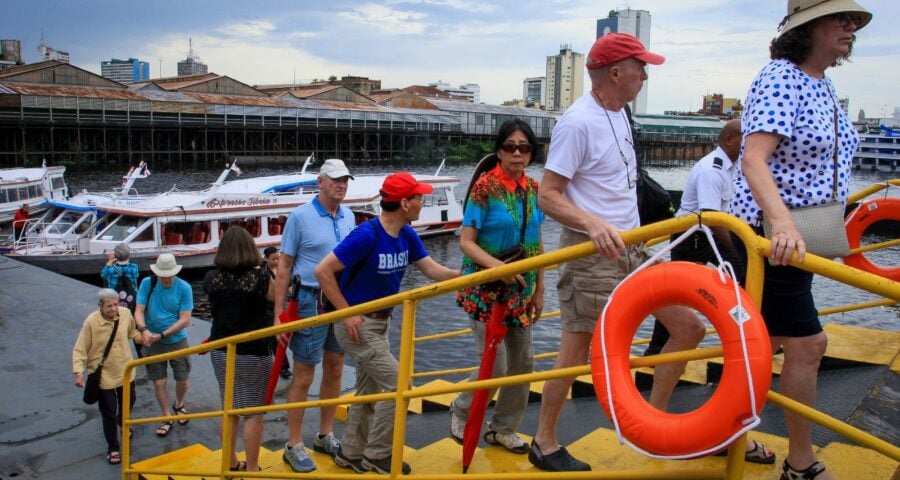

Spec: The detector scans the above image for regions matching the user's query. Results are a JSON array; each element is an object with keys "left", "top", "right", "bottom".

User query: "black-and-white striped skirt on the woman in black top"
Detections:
[{"left": 209, "top": 350, "right": 273, "bottom": 414}]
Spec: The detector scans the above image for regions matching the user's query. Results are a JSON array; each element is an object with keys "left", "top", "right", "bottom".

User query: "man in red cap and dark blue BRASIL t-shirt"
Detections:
[{"left": 315, "top": 172, "right": 459, "bottom": 474}]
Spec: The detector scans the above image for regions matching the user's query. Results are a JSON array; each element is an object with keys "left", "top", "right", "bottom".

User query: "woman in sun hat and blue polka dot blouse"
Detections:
[{"left": 730, "top": 0, "right": 872, "bottom": 480}]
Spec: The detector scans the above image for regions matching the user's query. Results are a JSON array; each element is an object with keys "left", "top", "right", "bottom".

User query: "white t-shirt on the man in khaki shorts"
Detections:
[{"left": 544, "top": 91, "right": 641, "bottom": 230}]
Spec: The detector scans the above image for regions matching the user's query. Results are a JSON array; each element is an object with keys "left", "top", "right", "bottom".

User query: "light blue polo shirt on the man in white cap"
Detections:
[{"left": 281, "top": 198, "right": 356, "bottom": 288}]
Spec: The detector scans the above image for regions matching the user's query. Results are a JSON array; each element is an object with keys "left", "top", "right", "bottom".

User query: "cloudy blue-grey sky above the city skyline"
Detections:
[{"left": 7, "top": 0, "right": 900, "bottom": 117}]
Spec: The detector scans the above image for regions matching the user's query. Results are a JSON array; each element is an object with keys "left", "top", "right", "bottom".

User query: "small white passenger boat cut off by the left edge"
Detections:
[{"left": 0, "top": 165, "right": 68, "bottom": 223}]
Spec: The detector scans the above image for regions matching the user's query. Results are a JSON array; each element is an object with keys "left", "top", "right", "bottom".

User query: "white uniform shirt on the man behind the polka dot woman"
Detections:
[{"left": 675, "top": 147, "right": 735, "bottom": 216}]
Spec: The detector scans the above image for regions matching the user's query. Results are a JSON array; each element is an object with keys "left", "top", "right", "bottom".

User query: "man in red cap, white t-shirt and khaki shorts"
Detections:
[{"left": 528, "top": 33, "right": 704, "bottom": 471}]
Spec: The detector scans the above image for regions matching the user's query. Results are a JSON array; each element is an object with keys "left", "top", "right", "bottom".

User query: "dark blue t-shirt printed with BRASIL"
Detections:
[{"left": 334, "top": 218, "right": 428, "bottom": 306}]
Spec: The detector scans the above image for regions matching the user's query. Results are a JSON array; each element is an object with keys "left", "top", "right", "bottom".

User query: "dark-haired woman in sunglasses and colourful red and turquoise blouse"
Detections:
[{"left": 450, "top": 118, "right": 544, "bottom": 454}]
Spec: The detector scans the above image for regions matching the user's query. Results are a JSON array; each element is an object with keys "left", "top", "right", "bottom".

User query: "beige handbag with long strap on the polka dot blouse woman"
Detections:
[{"left": 763, "top": 99, "right": 850, "bottom": 258}]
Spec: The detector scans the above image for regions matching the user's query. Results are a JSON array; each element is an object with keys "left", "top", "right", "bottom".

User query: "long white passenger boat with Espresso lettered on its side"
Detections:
[{"left": 8, "top": 160, "right": 462, "bottom": 275}]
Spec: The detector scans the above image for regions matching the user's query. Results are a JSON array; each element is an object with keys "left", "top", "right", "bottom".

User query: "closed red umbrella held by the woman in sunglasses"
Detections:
[{"left": 463, "top": 290, "right": 509, "bottom": 473}]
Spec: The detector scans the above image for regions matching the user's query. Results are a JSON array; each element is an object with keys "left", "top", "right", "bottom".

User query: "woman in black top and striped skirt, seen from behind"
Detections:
[{"left": 203, "top": 226, "right": 275, "bottom": 472}]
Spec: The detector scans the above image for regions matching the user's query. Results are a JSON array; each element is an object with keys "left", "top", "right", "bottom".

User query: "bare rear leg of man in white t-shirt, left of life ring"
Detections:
[{"left": 534, "top": 332, "right": 591, "bottom": 455}]
